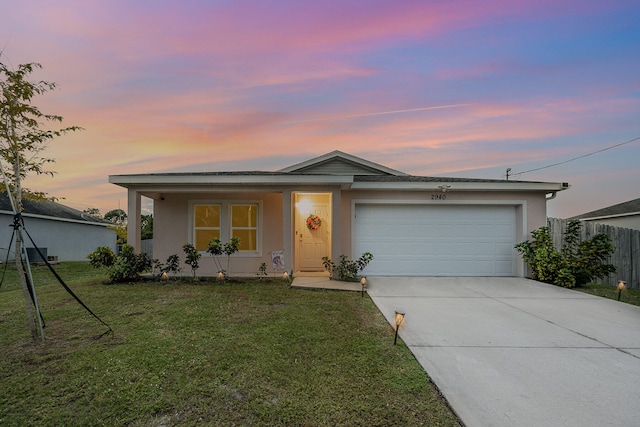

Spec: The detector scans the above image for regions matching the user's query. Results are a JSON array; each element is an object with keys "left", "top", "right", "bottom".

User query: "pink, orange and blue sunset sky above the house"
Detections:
[{"left": 0, "top": 0, "right": 640, "bottom": 217}]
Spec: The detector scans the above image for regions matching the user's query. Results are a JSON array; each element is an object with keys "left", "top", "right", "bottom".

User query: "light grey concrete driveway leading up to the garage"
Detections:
[{"left": 368, "top": 277, "right": 640, "bottom": 427}]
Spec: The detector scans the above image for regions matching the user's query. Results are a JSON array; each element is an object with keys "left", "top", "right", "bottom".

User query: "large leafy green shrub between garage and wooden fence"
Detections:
[{"left": 515, "top": 220, "right": 616, "bottom": 288}]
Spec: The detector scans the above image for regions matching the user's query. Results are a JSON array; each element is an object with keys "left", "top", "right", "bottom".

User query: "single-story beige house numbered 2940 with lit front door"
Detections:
[{"left": 109, "top": 151, "right": 569, "bottom": 276}]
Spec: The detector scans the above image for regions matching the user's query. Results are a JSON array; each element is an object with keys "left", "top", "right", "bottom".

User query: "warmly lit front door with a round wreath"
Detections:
[{"left": 296, "top": 193, "right": 331, "bottom": 271}]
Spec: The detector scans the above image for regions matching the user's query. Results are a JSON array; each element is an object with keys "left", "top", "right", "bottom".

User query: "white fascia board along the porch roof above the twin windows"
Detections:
[{"left": 109, "top": 175, "right": 353, "bottom": 187}]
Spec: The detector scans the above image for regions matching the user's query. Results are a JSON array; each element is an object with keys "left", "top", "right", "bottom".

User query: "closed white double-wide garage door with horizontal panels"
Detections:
[{"left": 354, "top": 204, "right": 516, "bottom": 276}]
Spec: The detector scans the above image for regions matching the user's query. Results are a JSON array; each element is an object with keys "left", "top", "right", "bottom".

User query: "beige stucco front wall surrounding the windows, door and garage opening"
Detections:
[{"left": 153, "top": 186, "right": 547, "bottom": 276}]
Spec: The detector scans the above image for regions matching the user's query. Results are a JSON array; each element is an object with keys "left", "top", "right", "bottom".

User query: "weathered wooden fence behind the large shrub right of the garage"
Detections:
[{"left": 547, "top": 218, "right": 640, "bottom": 289}]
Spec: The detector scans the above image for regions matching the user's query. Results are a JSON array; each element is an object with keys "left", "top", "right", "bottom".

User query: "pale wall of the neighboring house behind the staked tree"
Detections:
[{"left": 0, "top": 215, "right": 116, "bottom": 262}]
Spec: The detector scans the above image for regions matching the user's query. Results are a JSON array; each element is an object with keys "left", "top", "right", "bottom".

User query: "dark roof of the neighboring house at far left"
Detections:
[{"left": 0, "top": 192, "right": 113, "bottom": 226}]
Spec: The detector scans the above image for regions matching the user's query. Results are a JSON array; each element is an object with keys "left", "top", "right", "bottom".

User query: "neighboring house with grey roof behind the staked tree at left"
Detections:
[{"left": 0, "top": 192, "right": 116, "bottom": 262}]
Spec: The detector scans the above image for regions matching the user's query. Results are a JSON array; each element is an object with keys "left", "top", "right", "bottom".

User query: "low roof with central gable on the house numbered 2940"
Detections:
[{"left": 109, "top": 151, "right": 569, "bottom": 192}]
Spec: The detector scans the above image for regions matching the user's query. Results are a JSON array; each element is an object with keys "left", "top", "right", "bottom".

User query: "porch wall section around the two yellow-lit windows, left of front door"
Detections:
[{"left": 153, "top": 192, "right": 284, "bottom": 276}]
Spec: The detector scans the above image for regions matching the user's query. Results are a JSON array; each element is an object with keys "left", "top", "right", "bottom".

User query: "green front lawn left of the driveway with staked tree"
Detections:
[{"left": 0, "top": 263, "right": 458, "bottom": 426}]
